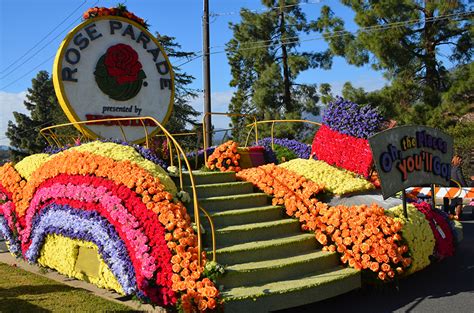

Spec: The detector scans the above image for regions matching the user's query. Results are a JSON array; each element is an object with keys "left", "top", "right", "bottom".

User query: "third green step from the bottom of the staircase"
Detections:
[{"left": 215, "top": 234, "right": 318, "bottom": 265}]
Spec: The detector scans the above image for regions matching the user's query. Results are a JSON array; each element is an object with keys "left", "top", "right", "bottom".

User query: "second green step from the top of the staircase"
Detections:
[{"left": 184, "top": 181, "right": 253, "bottom": 198}]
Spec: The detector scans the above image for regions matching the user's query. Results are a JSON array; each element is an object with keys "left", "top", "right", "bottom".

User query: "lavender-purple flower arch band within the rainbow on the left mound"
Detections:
[{"left": 25, "top": 203, "right": 137, "bottom": 295}]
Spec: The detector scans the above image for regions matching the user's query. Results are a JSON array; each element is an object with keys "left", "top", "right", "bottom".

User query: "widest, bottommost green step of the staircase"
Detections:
[{"left": 221, "top": 267, "right": 361, "bottom": 313}]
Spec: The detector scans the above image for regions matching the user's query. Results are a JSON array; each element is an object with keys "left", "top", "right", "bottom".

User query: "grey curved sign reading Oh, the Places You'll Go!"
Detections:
[{"left": 369, "top": 125, "right": 453, "bottom": 199}]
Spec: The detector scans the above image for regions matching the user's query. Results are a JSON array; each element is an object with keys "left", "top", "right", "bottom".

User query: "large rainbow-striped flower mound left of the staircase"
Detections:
[{"left": 0, "top": 141, "right": 219, "bottom": 311}]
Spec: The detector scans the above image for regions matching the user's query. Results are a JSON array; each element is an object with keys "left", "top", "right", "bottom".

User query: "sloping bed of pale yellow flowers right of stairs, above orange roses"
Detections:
[{"left": 278, "top": 159, "right": 374, "bottom": 195}]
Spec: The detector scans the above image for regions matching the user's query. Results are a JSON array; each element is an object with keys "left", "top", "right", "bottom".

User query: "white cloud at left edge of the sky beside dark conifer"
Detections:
[{"left": 0, "top": 91, "right": 29, "bottom": 146}]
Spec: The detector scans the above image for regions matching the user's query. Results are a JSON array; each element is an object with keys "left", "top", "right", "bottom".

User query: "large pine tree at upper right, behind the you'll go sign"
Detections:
[{"left": 315, "top": 0, "right": 473, "bottom": 124}]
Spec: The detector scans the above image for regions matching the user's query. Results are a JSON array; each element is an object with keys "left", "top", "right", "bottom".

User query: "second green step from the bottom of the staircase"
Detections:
[{"left": 218, "top": 250, "right": 339, "bottom": 289}]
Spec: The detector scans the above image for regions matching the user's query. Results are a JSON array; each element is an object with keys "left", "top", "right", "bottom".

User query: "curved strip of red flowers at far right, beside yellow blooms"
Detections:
[{"left": 413, "top": 202, "right": 454, "bottom": 260}]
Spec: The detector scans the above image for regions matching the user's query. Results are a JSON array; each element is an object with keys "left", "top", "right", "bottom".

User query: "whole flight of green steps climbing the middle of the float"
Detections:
[{"left": 180, "top": 171, "right": 361, "bottom": 312}]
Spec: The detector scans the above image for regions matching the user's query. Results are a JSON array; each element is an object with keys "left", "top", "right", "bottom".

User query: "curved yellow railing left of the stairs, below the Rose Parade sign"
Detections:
[{"left": 40, "top": 117, "right": 215, "bottom": 266}]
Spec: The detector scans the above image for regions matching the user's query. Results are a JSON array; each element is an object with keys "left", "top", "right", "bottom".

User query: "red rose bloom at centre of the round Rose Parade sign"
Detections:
[{"left": 104, "top": 43, "right": 142, "bottom": 85}]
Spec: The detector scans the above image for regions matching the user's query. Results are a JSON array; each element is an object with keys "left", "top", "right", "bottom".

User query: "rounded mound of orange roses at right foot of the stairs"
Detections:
[{"left": 308, "top": 203, "right": 411, "bottom": 281}]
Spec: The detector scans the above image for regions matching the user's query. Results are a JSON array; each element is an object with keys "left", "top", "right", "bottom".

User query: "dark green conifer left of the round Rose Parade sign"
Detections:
[{"left": 6, "top": 71, "right": 68, "bottom": 161}]
